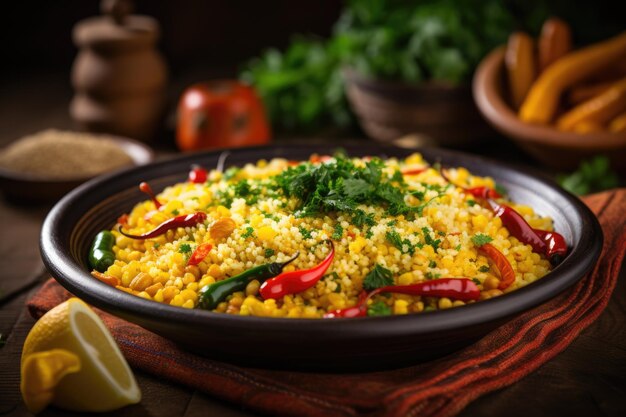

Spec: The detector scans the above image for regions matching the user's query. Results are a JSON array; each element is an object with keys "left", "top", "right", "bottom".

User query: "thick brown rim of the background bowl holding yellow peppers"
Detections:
[{"left": 472, "top": 46, "right": 626, "bottom": 151}]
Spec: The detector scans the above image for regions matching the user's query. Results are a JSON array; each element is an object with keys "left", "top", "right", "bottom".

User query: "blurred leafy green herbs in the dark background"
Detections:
[{"left": 241, "top": 0, "right": 624, "bottom": 132}]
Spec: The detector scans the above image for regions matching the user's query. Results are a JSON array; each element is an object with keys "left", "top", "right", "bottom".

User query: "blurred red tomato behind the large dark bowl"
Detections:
[{"left": 176, "top": 80, "right": 270, "bottom": 151}]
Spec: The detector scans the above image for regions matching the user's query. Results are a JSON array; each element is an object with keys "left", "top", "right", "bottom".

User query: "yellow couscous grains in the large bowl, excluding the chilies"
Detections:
[{"left": 91, "top": 154, "right": 552, "bottom": 318}]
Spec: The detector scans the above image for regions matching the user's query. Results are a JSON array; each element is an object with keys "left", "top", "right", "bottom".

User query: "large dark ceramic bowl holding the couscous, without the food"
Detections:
[{"left": 41, "top": 145, "right": 602, "bottom": 369}]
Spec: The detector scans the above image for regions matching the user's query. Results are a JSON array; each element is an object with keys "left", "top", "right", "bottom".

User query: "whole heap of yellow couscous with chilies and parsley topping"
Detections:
[{"left": 90, "top": 154, "right": 564, "bottom": 318}]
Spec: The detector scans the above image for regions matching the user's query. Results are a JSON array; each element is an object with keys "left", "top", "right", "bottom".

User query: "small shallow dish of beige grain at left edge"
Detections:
[{"left": 0, "top": 129, "right": 154, "bottom": 202}]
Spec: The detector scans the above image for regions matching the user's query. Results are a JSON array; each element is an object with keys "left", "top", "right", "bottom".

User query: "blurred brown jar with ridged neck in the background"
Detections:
[{"left": 70, "top": 7, "right": 167, "bottom": 141}]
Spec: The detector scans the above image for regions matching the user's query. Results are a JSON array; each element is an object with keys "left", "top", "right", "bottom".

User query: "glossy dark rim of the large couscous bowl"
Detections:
[{"left": 40, "top": 143, "right": 603, "bottom": 340}]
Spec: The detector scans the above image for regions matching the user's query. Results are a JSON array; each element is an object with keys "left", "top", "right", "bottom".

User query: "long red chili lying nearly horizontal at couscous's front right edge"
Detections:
[{"left": 324, "top": 278, "right": 480, "bottom": 318}]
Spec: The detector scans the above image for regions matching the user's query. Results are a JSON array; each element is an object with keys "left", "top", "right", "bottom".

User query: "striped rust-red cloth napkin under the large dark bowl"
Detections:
[{"left": 28, "top": 189, "right": 626, "bottom": 417}]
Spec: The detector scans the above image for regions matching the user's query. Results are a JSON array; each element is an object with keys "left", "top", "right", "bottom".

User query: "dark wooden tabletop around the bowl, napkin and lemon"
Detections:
[{"left": 0, "top": 77, "right": 626, "bottom": 417}]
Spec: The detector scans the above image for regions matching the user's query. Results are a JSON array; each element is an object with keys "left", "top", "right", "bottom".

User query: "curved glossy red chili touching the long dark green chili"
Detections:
[{"left": 259, "top": 241, "right": 335, "bottom": 300}]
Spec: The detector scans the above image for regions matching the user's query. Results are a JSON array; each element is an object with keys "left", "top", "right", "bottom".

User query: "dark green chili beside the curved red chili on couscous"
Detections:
[{"left": 198, "top": 252, "right": 300, "bottom": 310}]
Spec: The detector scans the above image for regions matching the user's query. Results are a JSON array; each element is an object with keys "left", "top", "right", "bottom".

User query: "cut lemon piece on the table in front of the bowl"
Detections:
[{"left": 20, "top": 298, "right": 141, "bottom": 413}]
